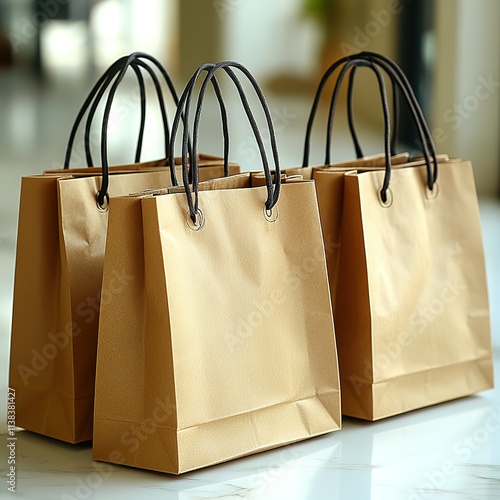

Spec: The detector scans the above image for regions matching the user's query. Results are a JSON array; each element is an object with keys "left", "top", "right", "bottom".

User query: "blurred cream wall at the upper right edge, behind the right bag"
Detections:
[{"left": 432, "top": 0, "right": 500, "bottom": 195}]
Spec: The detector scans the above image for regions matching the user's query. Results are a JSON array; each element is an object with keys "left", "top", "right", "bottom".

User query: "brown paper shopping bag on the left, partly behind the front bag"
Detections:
[{"left": 10, "top": 51, "right": 236, "bottom": 443}]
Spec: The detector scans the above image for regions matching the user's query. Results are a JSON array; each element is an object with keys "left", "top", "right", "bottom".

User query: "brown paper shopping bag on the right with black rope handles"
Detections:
[{"left": 335, "top": 55, "right": 493, "bottom": 420}]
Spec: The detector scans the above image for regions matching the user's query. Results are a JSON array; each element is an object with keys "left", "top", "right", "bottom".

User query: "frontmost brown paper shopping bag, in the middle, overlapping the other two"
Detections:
[{"left": 94, "top": 59, "right": 340, "bottom": 474}]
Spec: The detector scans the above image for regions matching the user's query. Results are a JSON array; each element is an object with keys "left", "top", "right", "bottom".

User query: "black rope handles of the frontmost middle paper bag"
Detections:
[{"left": 170, "top": 61, "right": 281, "bottom": 223}]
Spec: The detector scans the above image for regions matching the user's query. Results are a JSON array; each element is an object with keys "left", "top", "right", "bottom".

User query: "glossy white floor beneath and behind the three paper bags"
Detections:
[{"left": 0, "top": 69, "right": 500, "bottom": 500}]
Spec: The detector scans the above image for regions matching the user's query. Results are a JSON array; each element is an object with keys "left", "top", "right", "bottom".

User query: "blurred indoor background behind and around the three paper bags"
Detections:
[{"left": 0, "top": 0, "right": 500, "bottom": 430}]
